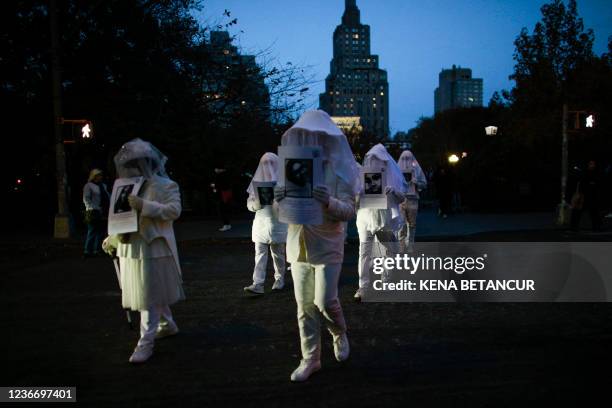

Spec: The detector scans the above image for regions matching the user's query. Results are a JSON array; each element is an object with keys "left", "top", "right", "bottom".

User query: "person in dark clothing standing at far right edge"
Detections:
[{"left": 571, "top": 160, "right": 602, "bottom": 231}]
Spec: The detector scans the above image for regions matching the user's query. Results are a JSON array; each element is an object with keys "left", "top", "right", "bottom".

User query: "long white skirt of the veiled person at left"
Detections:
[{"left": 119, "top": 256, "right": 185, "bottom": 310}]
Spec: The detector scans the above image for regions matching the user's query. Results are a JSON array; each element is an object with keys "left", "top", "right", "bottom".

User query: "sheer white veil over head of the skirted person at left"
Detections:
[{"left": 114, "top": 138, "right": 168, "bottom": 179}]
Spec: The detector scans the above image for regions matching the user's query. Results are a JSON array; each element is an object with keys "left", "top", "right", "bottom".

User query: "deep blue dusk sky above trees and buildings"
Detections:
[{"left": 196, "top": 0, "right": 612, "bottom": 134}]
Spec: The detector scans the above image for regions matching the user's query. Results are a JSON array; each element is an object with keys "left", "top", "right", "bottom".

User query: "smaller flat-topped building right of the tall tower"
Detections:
[{"left": 434, "top": 65, "right": 482, "bottom": 113}]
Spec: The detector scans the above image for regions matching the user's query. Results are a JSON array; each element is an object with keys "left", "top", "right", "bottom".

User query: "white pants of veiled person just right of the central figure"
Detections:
[{"left": 357, "top": 231, "right": 399, "bottom": 289}]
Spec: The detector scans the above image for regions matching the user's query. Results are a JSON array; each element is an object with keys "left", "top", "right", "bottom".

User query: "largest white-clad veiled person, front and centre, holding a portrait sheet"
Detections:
[{"left": 275, "top": 110, "right": 360, "bottom": 381}]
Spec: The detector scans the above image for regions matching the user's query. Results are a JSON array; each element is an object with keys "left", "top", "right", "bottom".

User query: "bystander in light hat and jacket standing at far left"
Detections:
[{"left": 83, "top": 169, "right": 109, "bottom": 257}]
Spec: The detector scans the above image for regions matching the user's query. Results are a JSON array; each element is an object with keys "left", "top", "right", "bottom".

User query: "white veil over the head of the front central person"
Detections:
[{"left": 281, "top": 110, "right": 361, "bottom": 194}]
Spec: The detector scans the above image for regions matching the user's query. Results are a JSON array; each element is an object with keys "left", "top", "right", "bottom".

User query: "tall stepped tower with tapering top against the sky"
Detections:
[{"left": 319, "top": 0, "right": 389, "bottom": 138}]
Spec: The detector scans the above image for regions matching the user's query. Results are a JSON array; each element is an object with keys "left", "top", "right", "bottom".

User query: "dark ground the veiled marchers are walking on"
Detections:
[{"left": 0, "top": 240, "right": 612, "bottom": 407}]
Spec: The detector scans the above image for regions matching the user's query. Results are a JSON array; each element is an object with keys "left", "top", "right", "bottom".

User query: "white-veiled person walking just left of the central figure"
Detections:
[{"left": 244, "top": 153, "right": 287, "bottom": 295}]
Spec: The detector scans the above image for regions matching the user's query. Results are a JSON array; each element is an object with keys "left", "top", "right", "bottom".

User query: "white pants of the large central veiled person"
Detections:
[{"left": 291, "top": 262, "right": 346, "bottom": 360}]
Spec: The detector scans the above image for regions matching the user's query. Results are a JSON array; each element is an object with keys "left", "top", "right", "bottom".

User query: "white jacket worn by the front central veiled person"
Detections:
[{"left": 287, "top": 165, "right": 355, "bottom": 265}]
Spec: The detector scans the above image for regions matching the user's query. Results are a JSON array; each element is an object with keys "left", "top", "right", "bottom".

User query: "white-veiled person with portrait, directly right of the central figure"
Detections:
[{"left": 355, "top": 143, "right": 408, "bottom": 300}]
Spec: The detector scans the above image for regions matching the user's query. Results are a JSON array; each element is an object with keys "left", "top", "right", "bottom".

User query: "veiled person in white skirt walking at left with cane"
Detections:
[{"left": 103, "top": 139, "right": 185, "bottom": 363}]
